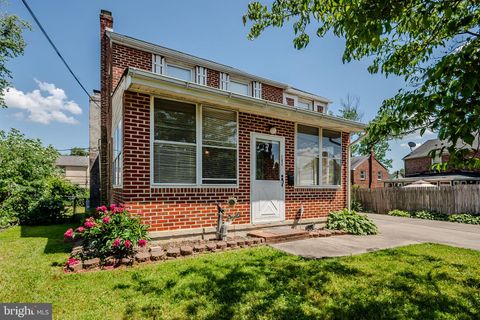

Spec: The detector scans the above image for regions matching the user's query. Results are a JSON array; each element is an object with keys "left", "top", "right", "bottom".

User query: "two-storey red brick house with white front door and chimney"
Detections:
[{"left": 100, "top": 10, "right": 365, "bottom": 231}]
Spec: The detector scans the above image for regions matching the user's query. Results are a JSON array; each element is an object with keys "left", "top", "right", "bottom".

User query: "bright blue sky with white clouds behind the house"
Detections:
[{"left": 0, "top": 0, "right": 433, "bottom": 170}]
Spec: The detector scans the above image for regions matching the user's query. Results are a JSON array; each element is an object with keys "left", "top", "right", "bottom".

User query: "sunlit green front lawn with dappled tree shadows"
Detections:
[{"left": 0, "top": 225, "right": 480, "bottom": 319}]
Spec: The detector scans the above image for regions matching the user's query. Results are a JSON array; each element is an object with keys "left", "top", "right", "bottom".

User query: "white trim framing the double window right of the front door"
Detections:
[{"left": 293, "top": 123, "right": 345, "bottom": 190}]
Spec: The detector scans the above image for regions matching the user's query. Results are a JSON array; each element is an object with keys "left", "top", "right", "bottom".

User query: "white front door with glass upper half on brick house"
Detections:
[{"left": 250, "top": 133, "right": 285, "bottom": 223}]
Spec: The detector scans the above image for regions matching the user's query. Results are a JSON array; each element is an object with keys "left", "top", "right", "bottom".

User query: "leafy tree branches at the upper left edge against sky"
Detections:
[{"left": 0, "top": 10, "right": 30, "bottom": 107}]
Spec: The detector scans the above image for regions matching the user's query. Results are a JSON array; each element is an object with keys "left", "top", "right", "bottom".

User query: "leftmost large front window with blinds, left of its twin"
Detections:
[{"left": 153, "top": 99, "right": 197, "bottom": 184}]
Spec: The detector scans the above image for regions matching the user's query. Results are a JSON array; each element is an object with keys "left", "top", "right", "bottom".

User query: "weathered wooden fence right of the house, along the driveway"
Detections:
[{"left": 352, "top": 185, "right": 480, "bottom": 214}]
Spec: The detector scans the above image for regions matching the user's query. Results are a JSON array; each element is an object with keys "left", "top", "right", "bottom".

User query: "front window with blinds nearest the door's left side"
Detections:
[{"left": 202, "top": 107, "right": 237, "bottom": 184}]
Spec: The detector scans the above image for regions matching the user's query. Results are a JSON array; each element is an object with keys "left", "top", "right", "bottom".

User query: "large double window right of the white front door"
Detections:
[{"left": 295, "top": 125, "right": 342, "bottom": 186}]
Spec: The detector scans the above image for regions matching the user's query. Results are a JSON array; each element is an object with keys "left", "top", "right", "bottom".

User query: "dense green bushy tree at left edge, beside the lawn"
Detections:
[{"left": 0, "top": 129, "right": 76, "bottom": 227}]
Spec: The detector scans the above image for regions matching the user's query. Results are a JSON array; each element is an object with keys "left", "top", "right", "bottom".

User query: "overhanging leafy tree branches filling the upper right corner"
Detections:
[{"left": 243, "top": 0, "right": 480, "bottom": 167}]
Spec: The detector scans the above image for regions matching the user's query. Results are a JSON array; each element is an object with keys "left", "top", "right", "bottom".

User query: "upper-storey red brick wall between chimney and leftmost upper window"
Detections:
[{"left": 112, "top": 43, "right": 152, "bottom": 90}]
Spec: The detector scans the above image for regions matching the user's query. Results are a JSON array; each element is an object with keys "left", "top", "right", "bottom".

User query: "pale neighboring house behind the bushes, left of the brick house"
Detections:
[{"left": 55, "top": 156, "right": 90, "bottom": 188}]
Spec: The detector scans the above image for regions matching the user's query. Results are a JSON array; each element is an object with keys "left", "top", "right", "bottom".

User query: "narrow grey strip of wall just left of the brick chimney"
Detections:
[{"left": 89, "top": 90, "right": 100, "bottom": 208}]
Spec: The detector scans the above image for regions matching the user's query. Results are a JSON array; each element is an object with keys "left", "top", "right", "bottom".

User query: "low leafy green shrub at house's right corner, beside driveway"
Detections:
[{"left": 326, "top": 209, "right": 378, "bottom": 235}]
